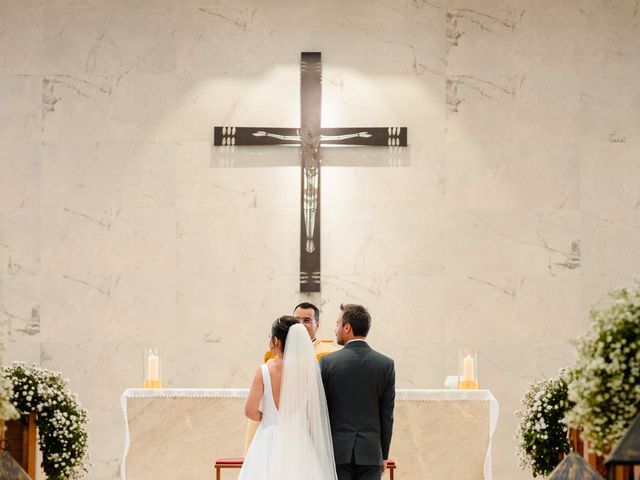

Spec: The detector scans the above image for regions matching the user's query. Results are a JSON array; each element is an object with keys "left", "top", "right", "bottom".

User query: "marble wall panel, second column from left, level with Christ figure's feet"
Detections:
[{"left": 42, "top": 206, "right": 176, "bottom": 278}]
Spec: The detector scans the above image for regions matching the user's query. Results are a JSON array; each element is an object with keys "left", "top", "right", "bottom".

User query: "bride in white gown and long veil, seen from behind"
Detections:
[{"left": 238, "top": 316, "right": 337, "bottom": 480}]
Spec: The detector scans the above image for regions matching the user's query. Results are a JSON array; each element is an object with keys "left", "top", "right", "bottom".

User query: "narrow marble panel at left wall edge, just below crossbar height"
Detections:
[{"left": 0, "top": 140, "right": 41, "bottom": 210}]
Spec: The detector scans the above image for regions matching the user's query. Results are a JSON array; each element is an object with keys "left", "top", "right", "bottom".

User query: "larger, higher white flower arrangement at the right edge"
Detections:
[{"left": 567, "top": 282, "right": 640, "bottom": 454}]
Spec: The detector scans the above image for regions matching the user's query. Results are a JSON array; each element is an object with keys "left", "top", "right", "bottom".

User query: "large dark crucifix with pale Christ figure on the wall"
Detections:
[{"left": 213, "top": 52, "right": 407, "bottom": 292}]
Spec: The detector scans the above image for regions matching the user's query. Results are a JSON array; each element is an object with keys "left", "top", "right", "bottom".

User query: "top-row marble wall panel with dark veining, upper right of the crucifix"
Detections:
[{"left": 447, "top": 0, "right": 581, "bottom": 75}]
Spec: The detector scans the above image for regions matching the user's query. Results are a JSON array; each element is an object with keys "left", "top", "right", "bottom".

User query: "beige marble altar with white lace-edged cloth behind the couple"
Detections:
[{"left": 121, "top": 389, "right": 498, "bottom": 480}]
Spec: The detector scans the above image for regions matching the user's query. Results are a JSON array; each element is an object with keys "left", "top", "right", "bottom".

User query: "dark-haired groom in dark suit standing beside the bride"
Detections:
[{"left": 320, "top": 305, "right": 395, "bottom": 480}]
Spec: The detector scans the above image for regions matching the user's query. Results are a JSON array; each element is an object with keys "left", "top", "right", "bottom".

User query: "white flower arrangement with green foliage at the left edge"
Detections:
[{"left": 4, "top": 362, "right": 89, "bottom": 480}]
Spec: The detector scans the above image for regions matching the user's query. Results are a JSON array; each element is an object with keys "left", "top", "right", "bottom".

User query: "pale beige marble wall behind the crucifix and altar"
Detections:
[{"left": 0, "top": 0, "right": 640, "bottom": 480}]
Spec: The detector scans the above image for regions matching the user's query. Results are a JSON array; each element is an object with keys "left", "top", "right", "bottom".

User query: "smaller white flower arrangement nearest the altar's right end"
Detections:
[{"left": 516, "top": 370, "right": 572, "bottom": 477}]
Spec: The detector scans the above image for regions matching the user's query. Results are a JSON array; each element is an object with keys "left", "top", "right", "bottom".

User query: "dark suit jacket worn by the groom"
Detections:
[{"left": 320, "top": 341, "right": 396, "bottom": 465}]
